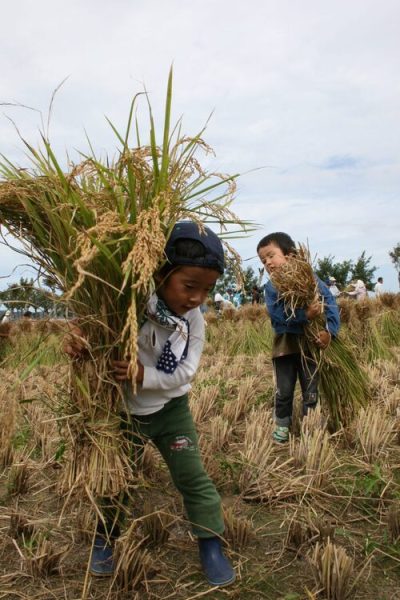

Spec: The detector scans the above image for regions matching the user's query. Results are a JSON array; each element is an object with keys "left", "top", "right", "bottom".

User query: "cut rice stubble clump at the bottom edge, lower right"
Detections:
[{"left": 308, "top": 541, "right": 356, "bottom": 600}]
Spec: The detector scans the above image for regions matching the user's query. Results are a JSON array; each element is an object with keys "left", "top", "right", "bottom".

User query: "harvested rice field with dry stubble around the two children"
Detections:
[{"left": 0, "top": 294, "right": 400, "bottom": 600}]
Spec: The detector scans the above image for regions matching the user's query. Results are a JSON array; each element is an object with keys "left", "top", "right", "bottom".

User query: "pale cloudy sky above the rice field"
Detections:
[{"left": 0, "top": 0, "right": 400, "bottom": 291}]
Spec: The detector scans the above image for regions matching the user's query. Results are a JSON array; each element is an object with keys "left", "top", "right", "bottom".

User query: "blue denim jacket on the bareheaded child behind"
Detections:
[{"left": 264, "top": 275, "right": 340, "bottom": 337}]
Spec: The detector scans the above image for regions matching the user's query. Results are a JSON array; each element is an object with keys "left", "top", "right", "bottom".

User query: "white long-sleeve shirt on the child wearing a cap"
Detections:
[{"left": 124, "top": 308, "right": 205, "bottom": 415}]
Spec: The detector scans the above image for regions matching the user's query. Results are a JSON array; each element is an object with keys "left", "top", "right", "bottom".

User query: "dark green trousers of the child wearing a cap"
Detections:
[{"left": 98, "top": 394, "right": 224, "bottom": 537}]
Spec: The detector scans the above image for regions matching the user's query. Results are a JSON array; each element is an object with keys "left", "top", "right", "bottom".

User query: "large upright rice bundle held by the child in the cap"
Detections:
[{"left": 0, "top": 72, "right": 248, "bottom": 496}]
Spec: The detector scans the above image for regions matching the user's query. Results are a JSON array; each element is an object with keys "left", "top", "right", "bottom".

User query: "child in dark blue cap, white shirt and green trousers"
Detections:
[{"left": 64, "top": 221, "right": 235, "bottom": 586}]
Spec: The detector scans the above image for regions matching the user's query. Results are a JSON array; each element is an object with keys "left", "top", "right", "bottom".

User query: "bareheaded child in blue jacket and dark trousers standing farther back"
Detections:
[{"left": 257, "top": 232, "right": 340, "bottom": 443}]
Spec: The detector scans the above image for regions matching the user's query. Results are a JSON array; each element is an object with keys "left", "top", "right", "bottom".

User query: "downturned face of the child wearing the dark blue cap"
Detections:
[{"left": 157, "top": 266, "right": 220, "bottom": 316}]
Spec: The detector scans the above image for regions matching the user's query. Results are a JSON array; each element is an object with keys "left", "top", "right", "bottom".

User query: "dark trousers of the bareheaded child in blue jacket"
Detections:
[{"left": 272, "top": 353, "right": 318, "bottom": 427}]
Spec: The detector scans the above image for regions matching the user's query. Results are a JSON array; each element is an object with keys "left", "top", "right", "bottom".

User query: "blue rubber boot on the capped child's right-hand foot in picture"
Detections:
[{"left": 198, "top": 537, "right": 236, "bottom": 587}]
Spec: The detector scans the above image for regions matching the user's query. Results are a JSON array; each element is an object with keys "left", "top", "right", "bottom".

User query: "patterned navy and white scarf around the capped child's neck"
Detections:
[{"left": 147, "top": 294, "right": 190, "bottom": 374}]
